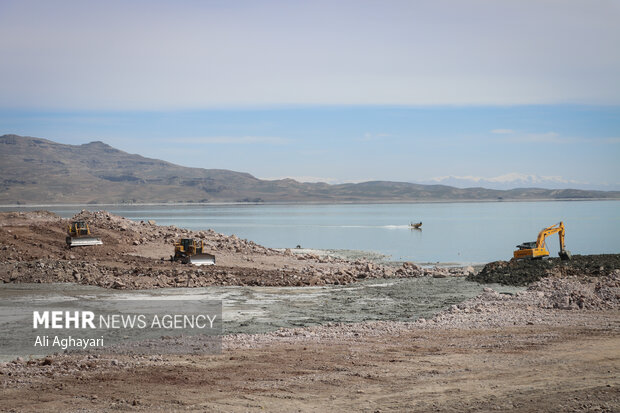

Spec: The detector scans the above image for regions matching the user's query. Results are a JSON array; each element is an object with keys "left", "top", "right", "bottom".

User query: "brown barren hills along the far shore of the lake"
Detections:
[{"left": 0, "top": 135, "right": 620, "bottom": 205}]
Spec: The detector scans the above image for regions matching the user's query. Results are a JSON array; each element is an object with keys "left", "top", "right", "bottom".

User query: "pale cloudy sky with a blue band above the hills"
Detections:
[{"left": 0, "top": 0, "right": 620, "bottom": 189}]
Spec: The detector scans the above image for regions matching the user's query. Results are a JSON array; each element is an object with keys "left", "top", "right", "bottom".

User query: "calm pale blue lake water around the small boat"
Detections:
[{"left": 1, "top": 201, "right": 620, "bottom": 263}]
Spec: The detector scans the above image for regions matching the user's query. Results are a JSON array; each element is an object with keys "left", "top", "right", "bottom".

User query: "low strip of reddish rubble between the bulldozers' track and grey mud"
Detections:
[{"left": 0, "top": 257, "right": 474, "bottom": 289}]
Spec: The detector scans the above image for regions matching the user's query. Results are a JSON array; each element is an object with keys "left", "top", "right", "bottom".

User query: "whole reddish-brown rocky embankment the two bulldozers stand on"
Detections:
[{"left": 0, "top": 211, "right": 473, "bottom": 289}]
